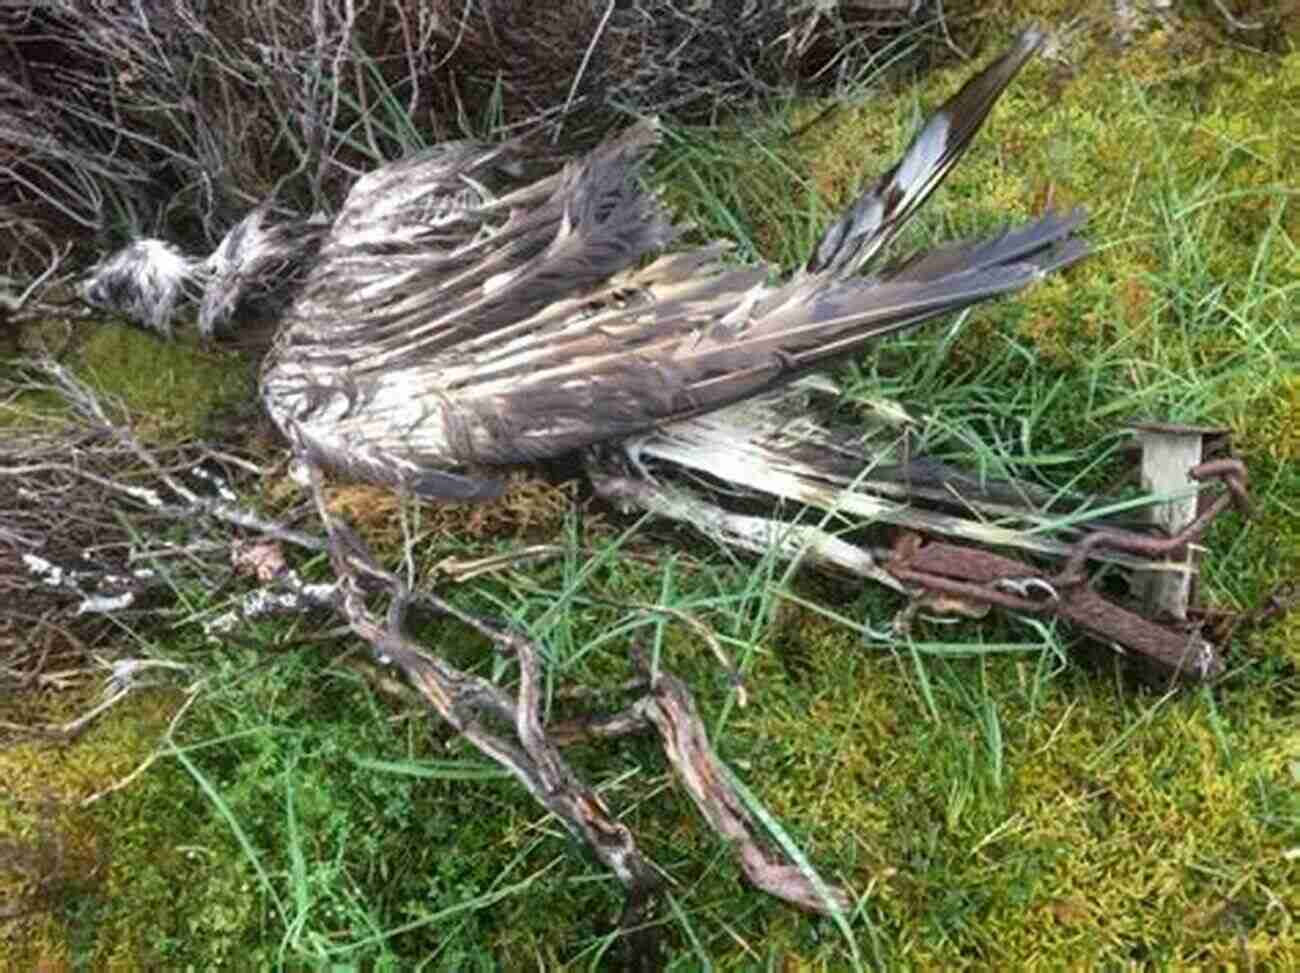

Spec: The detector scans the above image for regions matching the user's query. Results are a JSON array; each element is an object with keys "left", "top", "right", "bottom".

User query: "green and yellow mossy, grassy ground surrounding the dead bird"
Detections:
[{"left": 0, "top": 9, "right": 1300, "bottom": 969}]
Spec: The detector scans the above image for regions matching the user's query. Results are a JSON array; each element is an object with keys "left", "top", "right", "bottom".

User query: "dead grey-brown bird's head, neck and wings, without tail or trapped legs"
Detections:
[{"left": 76, "top": 30, "right": 1087, "bottom": 500}]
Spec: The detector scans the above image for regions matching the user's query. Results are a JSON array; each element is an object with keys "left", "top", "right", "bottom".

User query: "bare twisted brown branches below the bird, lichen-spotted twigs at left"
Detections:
[{"left": 0, "top": 359, "right": 853, "bottom": 969}]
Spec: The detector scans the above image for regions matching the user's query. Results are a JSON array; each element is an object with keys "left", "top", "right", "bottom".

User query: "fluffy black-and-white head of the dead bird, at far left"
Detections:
[{"left": 77, "top": 239, "right": 200, "bottom": 338}]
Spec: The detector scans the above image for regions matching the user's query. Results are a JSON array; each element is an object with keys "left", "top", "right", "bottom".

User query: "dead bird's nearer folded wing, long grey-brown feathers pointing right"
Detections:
[{"left": 264, "top": 215, "right": 1086, "bottom": 497}]
